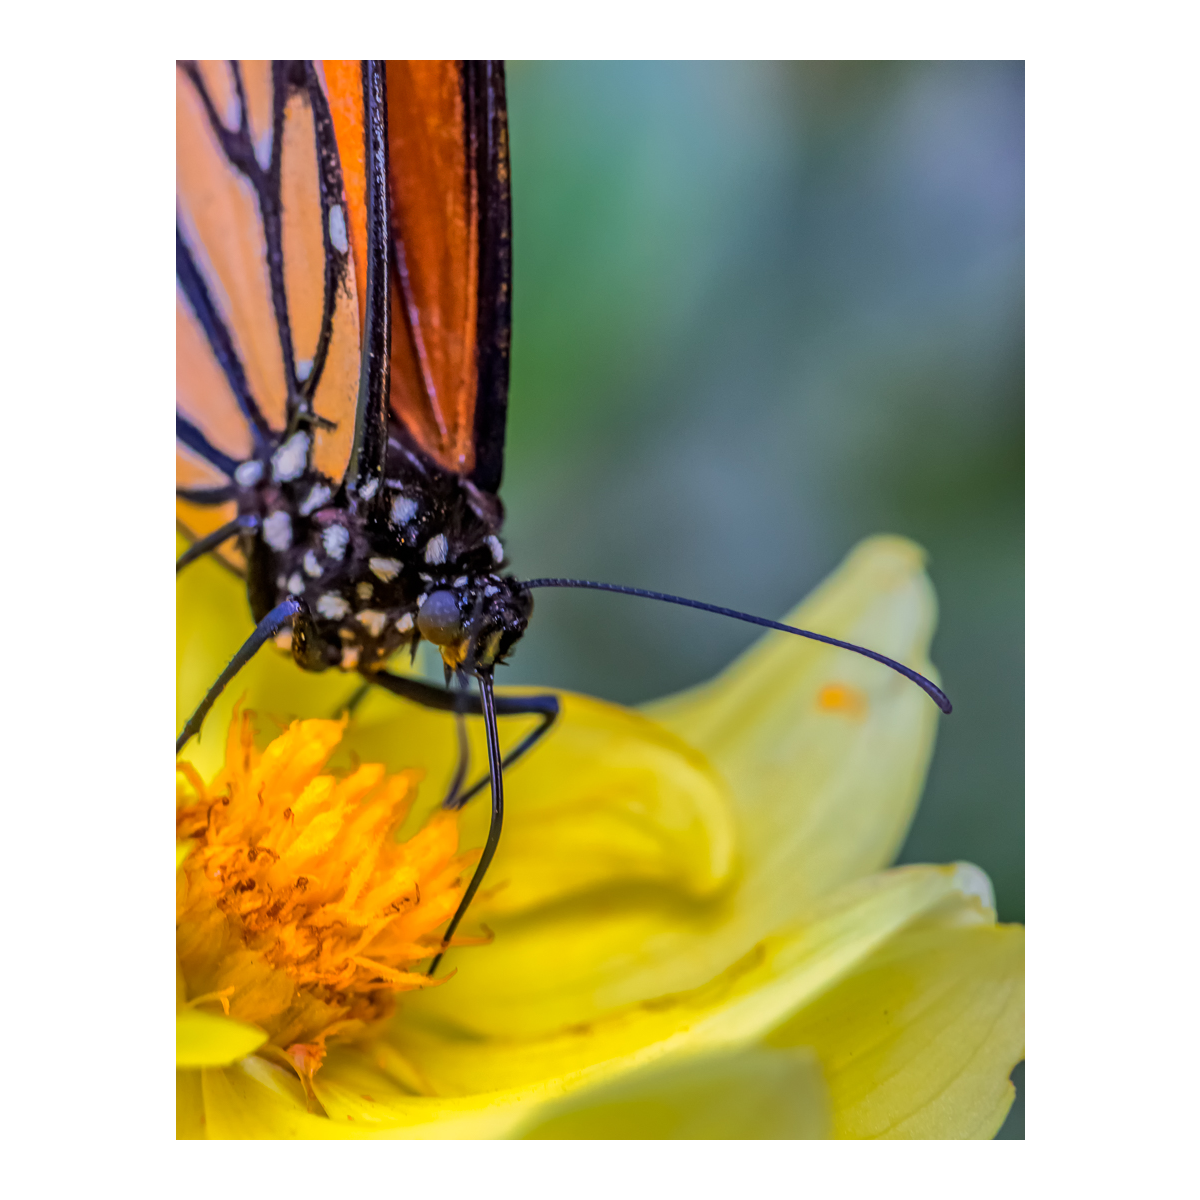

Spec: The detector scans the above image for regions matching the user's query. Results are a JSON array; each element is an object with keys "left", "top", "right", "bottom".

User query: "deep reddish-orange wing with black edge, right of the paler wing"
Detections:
[{"left": 324, "top": 61, "right": 511, "bottom": 492}]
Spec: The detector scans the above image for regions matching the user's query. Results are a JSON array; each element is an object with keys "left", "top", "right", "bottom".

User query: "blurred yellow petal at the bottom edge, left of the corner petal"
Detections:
[{"left": 516, "top": 1046, "right": 829, "bottom": 1140}]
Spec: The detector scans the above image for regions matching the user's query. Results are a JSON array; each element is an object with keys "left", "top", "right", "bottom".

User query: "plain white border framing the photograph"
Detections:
[{"left": 9, "top": 0, "right": 1198, "bottom": 1196}]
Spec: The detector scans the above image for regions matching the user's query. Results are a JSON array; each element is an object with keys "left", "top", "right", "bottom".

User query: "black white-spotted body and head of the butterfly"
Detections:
[{"left": 235, "top": 427, "right": 533, "bottom": 672}]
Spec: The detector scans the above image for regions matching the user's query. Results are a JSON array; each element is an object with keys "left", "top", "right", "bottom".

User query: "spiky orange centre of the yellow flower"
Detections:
[{"left": 176, "top": 713, "right": 479, "bottom": 1081}]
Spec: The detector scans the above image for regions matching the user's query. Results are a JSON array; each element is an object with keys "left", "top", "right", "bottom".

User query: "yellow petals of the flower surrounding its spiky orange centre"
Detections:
[{"left": 178, "top": 538, "right": 1024, "bottom": 1138}]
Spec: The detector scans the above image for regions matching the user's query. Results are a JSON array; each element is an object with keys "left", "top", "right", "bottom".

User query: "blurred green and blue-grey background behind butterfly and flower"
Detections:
[{"left": 503, "top": 62, "right": 1025, "bottom": 1138}]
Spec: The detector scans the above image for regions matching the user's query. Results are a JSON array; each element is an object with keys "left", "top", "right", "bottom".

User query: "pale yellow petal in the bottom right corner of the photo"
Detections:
[{"left": 769, "top": 873, "right": 1025, "bottom": 1138}]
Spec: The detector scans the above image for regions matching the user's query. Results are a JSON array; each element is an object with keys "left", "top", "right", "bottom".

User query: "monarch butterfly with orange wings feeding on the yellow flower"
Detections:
[{"left": 175, "top": 60, "right": 950, "bottom": 973}]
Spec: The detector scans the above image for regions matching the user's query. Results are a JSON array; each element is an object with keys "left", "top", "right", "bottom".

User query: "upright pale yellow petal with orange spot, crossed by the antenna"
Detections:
[{"left": 644, "top": 536, "right": 940, "bottom": 912}]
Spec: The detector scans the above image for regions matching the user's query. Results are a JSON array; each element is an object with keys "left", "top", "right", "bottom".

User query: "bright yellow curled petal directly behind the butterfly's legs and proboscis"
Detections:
[{"left": 347, "top": 689, "right": 734, "bottom": 924}]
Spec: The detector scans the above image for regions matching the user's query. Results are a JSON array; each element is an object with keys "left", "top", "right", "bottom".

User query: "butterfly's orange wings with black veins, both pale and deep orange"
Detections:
[{"left": 176, "top": 61, "right": 511, "bottom": 565}]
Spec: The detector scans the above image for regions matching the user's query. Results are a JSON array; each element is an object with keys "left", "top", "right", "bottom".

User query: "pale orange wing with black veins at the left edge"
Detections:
[{"left": 175, "top": 62, "right": 360, "bottom": 563}]
